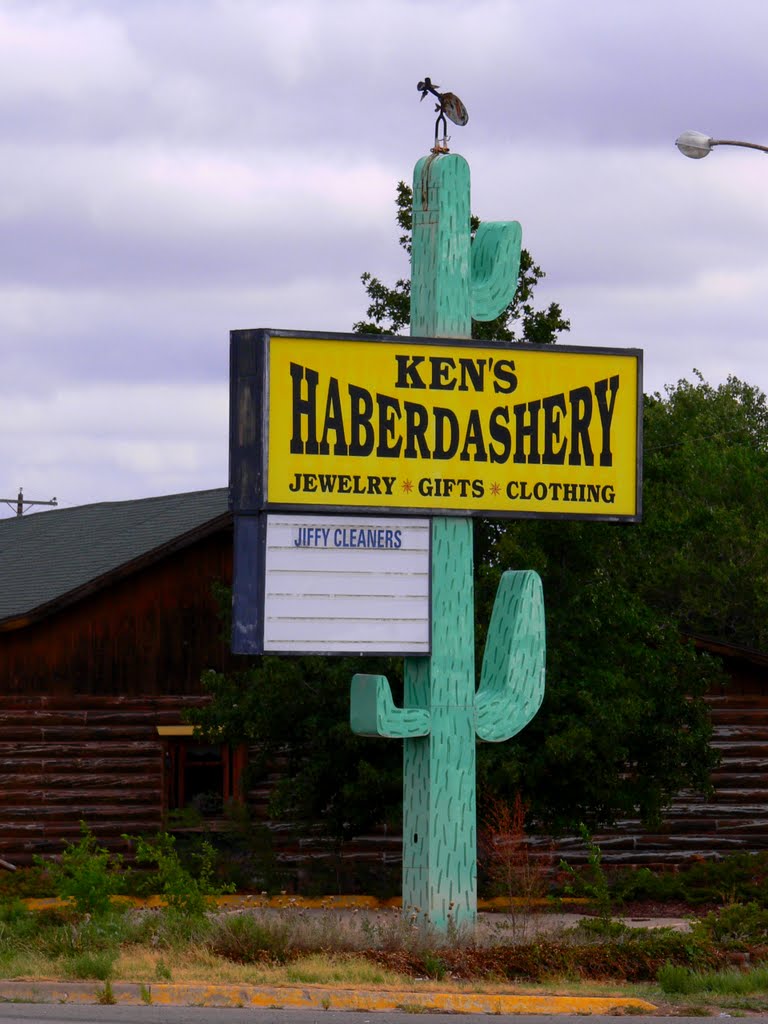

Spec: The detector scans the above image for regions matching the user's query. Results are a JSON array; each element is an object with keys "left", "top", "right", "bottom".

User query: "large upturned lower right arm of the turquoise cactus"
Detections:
[{"left": 475, "top": 570, "right": 546, "bottom": 742}]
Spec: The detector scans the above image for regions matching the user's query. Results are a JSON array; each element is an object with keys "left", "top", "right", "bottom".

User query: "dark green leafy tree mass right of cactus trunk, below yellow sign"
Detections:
[{"left": 476, "top": 507, "right": 720, "bottom": 831}]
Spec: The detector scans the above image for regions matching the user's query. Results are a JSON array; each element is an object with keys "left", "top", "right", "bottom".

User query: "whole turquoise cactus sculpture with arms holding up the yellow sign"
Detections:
[{"left": 350, "top": 154, "right": 545, "bottom": 930}]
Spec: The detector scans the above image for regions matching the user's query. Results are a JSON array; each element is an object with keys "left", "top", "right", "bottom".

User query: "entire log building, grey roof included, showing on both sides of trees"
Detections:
[{"left": 0, "top": 488, "right": 768, "bottom": 867}]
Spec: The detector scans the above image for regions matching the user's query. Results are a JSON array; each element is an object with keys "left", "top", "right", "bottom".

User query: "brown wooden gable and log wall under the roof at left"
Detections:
[{"left": 0, "top": 525, "right": 232, "bottom": 865}]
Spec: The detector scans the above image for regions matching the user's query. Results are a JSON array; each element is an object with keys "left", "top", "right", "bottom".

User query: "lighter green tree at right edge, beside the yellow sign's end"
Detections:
[{"left": 638, "top": 372, "right": 768, "bottom": 649}]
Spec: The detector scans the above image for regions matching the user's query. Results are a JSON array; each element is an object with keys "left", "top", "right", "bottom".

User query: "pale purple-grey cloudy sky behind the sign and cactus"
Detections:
[{"left": 0, "top": 0, "right": 768, "bottom": 515}]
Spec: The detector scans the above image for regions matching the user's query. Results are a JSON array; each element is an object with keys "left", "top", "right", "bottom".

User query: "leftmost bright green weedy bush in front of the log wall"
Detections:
[{"left": 35, "top": 821, "right": 123, "bottom": 915}]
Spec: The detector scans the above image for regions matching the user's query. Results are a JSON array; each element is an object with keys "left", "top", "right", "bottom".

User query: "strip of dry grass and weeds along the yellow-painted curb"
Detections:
[{"left": 0, "top": 907, "right": 768, "bottom": 1015}]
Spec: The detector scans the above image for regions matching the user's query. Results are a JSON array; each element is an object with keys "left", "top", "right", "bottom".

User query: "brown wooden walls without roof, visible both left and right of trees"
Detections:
[{"left": 0, "top": 501, "right": 768, "bottom": 869}]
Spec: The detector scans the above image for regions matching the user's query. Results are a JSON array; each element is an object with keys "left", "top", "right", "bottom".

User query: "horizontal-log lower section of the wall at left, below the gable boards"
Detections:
[{"left": 0, "top": 694, "right": 208, "bottom": 866}]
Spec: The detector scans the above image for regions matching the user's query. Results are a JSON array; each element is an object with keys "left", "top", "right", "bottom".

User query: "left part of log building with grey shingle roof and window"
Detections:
[{"left": 0, "top": 488, "right": 236, "bottom": 864}]
